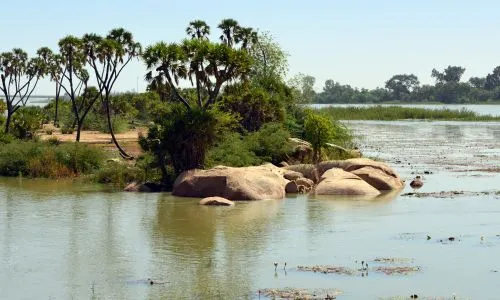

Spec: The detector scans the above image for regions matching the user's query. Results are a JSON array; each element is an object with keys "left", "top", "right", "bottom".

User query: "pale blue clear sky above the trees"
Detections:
[{"left": 0, "top": 0, "right": 500, "bottom": 95}]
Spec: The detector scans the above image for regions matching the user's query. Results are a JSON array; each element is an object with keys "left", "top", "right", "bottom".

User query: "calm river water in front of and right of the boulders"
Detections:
[{"left": 0, "top": 121, "right": 500, "bottom": 300}]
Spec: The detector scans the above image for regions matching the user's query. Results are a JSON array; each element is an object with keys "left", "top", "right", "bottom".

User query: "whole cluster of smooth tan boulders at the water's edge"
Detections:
[{"left": 172, "top": 158, "right": 404, "bottom": 204}]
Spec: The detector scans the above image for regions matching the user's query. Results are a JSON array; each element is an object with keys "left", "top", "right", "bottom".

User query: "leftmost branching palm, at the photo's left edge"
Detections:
[{"left": 0, "top": 48, "right": 46, "bottom": 132}]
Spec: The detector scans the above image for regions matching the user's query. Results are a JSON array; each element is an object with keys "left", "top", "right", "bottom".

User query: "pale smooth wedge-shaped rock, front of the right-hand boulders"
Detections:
[{"left": 315, "top": 168, "right": 380, "bottom": 196}]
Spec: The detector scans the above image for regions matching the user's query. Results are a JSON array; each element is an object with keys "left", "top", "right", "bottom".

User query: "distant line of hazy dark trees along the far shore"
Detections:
[{"left": 290, "top": 66, "right": 500, "bottom": 103}]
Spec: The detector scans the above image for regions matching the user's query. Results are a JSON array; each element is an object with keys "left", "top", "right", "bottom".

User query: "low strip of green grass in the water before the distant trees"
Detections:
[{"left": 319, "top": 105, "right": 500, "bottom": 121}]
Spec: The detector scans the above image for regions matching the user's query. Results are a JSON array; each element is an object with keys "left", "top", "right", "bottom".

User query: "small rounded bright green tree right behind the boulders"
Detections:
[{"left": 304, "top": 112, "right": 334, "bottom": 162}]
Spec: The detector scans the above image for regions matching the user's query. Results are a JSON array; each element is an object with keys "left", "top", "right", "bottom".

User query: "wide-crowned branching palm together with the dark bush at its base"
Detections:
[{"left": 142, "top": 19, "right": 252, "bottom": 174}]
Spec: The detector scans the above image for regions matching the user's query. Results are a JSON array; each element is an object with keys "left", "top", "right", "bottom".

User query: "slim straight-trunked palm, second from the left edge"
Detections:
[{"left": 37, "top": 47, "right": 63, "bottom": 126}]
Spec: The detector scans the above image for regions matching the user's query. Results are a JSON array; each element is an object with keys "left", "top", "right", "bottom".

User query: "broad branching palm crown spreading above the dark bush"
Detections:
[{"left": 143, "top": 40, "right": 251, "bottom": 110}]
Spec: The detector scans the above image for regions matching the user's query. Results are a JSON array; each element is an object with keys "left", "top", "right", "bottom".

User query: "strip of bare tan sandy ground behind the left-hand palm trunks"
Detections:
[{"left": 38, "top": 125, "right": 147, "bottom": 157}]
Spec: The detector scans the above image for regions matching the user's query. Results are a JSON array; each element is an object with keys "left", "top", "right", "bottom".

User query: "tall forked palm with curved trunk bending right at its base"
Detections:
[{"left": 82, "top": 28, "right": 141, "bottom": 159}]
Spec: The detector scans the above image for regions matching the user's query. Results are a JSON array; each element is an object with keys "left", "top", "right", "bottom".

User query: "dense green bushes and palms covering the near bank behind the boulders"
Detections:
[{"left": 0, "top": 19, "right": 362, "bottom": 188}]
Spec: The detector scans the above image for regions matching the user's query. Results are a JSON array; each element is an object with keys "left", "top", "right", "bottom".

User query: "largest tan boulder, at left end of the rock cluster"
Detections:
[{"left": 172, "top": 164, "right": 288, "bottom": 200}]
